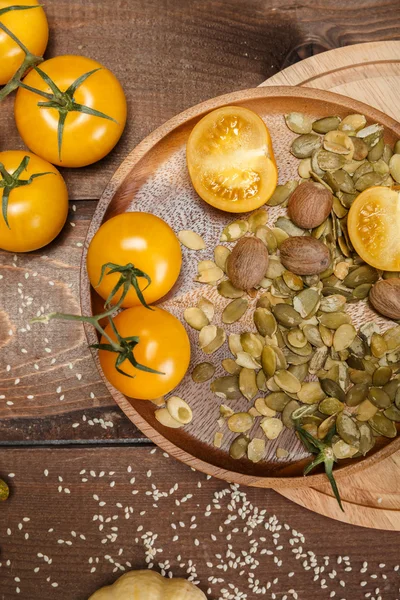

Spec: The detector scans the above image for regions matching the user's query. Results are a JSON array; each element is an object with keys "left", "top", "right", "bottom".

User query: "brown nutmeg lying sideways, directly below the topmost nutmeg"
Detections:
[{"left": 280, "top": 236, "right": 331, "bottom": 275}]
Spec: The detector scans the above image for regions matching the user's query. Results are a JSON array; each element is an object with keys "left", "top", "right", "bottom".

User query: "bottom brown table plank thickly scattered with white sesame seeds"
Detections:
[{"left": 0, "top": 448, "right": 399, "bottom": 600}]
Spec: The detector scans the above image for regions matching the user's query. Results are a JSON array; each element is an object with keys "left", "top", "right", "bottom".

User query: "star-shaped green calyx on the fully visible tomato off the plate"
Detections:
[{"left": 18, "top": 67, "right": 117, "bottom": 161}]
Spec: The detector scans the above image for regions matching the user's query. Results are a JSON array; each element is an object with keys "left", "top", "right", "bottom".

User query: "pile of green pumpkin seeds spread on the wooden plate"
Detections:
[{"left": 179, "top": 113, "right": 400, "bottom": 492}]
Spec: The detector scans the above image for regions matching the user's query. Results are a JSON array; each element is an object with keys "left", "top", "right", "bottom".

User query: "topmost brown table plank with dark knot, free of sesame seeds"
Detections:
[{"left": 0, "top": 0, "right": 400, "bottom": 199}]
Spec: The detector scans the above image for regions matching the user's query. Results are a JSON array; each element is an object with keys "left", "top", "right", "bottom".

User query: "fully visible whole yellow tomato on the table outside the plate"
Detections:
[{"left": 14, "top": 56, "right": 127, "bottom": 167}]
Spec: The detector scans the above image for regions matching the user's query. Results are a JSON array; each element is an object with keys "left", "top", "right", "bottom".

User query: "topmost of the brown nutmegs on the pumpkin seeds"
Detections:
[{"left": 288, "top": 181, "right": 333, "bottom": 229}]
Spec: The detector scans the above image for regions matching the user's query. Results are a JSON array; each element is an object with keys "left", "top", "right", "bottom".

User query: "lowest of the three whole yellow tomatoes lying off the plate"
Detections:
[{"left": 0, "top": 150, "right": 68, "bottom": 252}]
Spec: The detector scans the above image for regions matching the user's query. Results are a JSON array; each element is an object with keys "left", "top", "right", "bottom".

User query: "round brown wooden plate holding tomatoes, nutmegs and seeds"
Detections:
[{"left": 81, "top": 87, "right": 400, "bottom": 487}]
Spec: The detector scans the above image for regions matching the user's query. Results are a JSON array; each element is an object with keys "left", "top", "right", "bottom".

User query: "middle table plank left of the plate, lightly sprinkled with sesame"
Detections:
[{"left": 0, "top": 202, "right": 143, "bottom": 443}]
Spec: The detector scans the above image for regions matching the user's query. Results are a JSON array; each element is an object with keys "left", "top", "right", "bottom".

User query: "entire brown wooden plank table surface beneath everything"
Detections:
[{"left": 0, "top": 0, "right": 400, "bottom": 600}]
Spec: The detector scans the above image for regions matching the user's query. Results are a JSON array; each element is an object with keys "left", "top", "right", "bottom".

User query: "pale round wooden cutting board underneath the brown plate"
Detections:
[{"left": 261, "top": 41, "right": 400, "bottom": 531}]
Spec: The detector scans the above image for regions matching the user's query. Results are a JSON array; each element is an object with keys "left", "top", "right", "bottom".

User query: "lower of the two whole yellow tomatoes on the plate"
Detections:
[{"left": 99, "top": 306, "right": 190, "bottom": 400}]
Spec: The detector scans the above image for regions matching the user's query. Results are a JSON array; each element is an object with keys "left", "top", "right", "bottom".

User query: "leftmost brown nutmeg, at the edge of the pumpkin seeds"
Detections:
[{"left": 226, "top": 237, "right": 269, "bottom": 291}]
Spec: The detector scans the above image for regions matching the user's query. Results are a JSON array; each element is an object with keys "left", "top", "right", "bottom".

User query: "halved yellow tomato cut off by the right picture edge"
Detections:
[{"left": 347, "top": 186, "right": 400, "bottom": 271}]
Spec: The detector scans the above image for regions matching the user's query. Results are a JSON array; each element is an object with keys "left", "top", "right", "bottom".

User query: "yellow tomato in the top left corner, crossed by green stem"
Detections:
[{"left": 0, "top": 0, "right": 49, "bottom": 85}]
